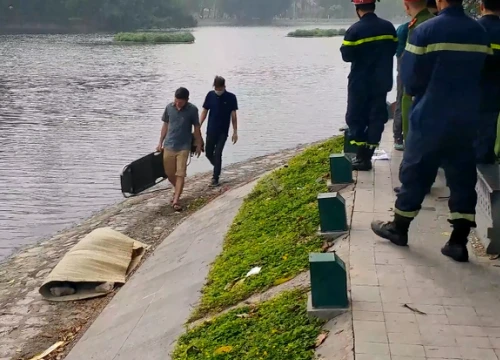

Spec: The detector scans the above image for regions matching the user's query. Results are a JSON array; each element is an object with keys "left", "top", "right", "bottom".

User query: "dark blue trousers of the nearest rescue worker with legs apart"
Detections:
[{"left": 395, "top": 131, "right": 477, "bottom": 222}]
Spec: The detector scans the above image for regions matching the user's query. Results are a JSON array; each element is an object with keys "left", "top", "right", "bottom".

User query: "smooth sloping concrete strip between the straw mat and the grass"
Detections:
[{"left": 66, "top": 182, "right": 255, "bottom": 360}]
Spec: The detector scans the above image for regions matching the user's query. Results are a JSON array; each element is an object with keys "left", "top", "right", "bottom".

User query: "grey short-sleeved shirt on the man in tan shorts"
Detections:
[{"left": 162, "top": 102, "right": 200, "bottom": 151}]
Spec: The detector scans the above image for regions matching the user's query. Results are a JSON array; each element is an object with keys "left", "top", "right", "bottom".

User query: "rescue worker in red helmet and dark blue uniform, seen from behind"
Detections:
[{"left": 340, "top": 0, "right": 398, "bottom": 171}]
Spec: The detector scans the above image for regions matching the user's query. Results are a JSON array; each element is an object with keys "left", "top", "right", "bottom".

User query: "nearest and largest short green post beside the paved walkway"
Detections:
[{"left": 309, "top": 253, "right": 349, "bottom": 309}]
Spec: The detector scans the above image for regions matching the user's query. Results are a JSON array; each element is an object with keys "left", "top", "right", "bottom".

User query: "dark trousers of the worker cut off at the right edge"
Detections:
[{"left": 474, "top": 112, "right": 499, "bottom": 164}]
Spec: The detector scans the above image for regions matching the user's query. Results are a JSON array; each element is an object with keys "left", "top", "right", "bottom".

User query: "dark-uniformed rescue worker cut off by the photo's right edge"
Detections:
[{"left": 476, "top": 0, "right": 500, "bottom": 164}]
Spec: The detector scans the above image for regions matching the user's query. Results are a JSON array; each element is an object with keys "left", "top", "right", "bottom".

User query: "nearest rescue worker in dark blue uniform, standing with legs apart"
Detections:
[{"left": 371, "top": 0, "right": 492, "bottom": 262}]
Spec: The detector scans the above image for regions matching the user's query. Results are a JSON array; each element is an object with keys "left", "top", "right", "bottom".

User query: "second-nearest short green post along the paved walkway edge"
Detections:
[{"left": 318, "top": 192, "right": 348, "bottom": 233}]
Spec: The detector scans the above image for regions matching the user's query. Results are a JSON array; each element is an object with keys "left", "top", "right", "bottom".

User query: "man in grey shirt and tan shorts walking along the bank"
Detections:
[{"left": 157, "top": 87, "right": 203, "bottom": 211}]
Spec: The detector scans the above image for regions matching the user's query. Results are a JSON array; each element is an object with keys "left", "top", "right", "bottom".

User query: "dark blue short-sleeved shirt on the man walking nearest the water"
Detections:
[{"left": 203, "top": 90, "right": 238, "bottom": 136}]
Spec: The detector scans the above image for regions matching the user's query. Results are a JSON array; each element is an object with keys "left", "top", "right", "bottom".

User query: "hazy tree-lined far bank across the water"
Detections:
[{"left": 0, "top": 0, "right": 479, "bottom": 30}]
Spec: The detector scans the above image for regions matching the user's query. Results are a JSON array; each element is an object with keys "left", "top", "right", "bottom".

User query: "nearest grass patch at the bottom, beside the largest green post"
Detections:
[{"left": 173, "top": 290, "right": 323, "bottom": 360}]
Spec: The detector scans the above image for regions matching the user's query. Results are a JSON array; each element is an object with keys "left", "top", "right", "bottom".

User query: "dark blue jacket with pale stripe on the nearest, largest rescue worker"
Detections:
[{"left": 401, "top": 6, "right": 492, "bottom": 141}]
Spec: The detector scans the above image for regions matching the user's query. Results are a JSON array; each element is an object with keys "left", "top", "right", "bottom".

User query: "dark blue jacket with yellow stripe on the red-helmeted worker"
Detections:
[{"left": 340, "top": 13, "right": 398, "bottom": 94}]
